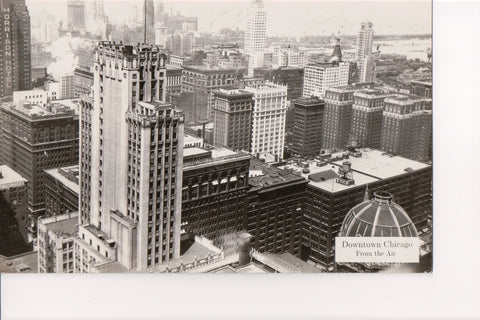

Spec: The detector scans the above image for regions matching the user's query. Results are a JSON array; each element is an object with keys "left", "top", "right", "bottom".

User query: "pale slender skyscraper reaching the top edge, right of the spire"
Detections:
[{"left": 244, "top": 0, "right": 267, "bottom": 55}]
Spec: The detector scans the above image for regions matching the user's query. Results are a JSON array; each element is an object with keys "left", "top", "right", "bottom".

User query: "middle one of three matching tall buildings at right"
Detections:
[{"left": 351, "top": 89, "right": 391, "bottom": 149}]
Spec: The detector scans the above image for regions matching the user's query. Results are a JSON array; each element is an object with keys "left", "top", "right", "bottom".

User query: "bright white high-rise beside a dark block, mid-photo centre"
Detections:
[{"left": 245, "top": 82, "right": 287, "bottom": 161}]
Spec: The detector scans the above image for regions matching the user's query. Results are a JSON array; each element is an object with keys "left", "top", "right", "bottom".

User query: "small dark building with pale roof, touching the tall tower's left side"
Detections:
[{"left": 45, "top": 165, "right": 80, "bottom": 217}]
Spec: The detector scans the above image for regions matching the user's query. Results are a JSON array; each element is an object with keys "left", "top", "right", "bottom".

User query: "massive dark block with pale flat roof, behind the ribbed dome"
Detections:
[{"left": 285, "top": 149, "right": 432, "bottom": 271}]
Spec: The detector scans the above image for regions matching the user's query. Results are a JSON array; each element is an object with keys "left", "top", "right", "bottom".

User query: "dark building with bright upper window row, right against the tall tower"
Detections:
[{"left": 182, "top": 148, "right": 250, "bottom": 245}]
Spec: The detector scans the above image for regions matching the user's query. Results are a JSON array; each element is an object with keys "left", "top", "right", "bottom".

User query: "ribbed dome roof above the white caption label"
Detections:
[{"left": 340, "top": 192, "right": 417, "bottom": 237}]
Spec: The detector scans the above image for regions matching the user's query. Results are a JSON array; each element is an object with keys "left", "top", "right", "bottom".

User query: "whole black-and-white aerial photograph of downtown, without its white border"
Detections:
[{"left": 0, "top": 0, "right": 435, "bottom": 274}]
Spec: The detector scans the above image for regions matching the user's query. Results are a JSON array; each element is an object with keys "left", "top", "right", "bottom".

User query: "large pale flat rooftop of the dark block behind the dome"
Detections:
[{"left": 281, "top": 148, "right": 431, "bottom": 193}]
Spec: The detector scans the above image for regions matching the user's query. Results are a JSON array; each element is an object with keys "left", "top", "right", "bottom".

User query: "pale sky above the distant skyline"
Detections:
[{"left": 27, "top": 0, "right": 432, "bottom": 36}]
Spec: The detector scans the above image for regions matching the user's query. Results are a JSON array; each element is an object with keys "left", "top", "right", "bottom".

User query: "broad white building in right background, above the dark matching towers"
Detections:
[{"left": 303, "top": 62, "right": 350, "bottom": 97}]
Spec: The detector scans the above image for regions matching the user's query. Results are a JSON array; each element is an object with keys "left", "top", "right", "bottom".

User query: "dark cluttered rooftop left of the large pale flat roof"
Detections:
[{"left": 248, "top": 158, "right": 307, "bottom": 190}]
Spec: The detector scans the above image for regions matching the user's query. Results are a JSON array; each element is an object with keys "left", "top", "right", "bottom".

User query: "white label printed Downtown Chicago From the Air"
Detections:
[{"left": 335, "top": 237, "right": 420, "bottom": 263}]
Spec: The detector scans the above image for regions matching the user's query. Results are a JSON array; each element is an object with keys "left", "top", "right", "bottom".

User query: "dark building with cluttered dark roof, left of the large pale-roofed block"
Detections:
[{"left": 243, "top": 159, "right": 308, "bottom": 257}]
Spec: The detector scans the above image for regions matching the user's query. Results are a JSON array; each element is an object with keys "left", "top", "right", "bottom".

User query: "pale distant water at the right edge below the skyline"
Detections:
[{"left": 373, "top": 38, "right": 432, "bottom": 61}]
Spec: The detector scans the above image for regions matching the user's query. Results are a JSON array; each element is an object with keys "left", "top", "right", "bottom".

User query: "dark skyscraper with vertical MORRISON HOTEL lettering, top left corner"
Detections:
[{"left": 0, "top": 0, "right": 32, "bottom": 97}]
